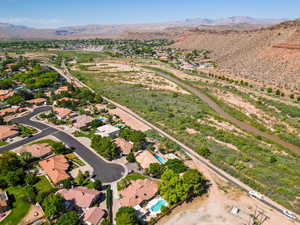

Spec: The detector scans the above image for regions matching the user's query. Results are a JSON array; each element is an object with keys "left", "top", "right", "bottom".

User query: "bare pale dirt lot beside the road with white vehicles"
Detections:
[{"left": 158, "top": 161, "right": 296, "bottom": 225}]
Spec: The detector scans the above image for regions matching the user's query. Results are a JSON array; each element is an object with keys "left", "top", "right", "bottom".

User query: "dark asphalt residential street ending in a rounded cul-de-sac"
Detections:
[{"left": 0, "top": 106, "right": 125, "bottom": 183}]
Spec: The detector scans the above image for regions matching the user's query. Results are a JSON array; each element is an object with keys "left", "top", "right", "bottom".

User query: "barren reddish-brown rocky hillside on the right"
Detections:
[{"left": 173, "top": 20, "right": 300, "bottom": 90}]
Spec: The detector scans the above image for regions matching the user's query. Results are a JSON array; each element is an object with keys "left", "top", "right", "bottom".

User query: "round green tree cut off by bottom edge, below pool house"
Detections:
[{"left": 116, "top": 207, "right": 138, "bottom": 225}]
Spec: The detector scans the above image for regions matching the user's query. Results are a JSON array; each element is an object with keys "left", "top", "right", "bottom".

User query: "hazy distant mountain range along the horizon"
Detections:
[{"left": 0, "top": 16, "right": 286, "bottom": 39}]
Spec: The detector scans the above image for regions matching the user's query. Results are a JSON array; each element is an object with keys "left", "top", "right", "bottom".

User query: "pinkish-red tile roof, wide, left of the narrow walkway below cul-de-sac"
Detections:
[{"left": 57, "top": 187, "right": 101, "bottom": 211}]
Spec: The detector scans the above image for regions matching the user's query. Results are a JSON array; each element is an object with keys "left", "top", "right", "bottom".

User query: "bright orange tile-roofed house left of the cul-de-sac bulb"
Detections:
[{"left": 39, "top": 155, "right": 70, "bottom": 184}]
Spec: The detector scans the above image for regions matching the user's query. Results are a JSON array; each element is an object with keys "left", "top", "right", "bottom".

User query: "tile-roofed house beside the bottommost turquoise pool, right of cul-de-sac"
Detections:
[{"left": 120, "top": 179, "right": 158, "bottom": 207}]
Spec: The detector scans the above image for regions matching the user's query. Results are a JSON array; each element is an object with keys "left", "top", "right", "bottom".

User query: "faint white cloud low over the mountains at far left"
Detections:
[{"left": 0, "top": 18, "right": 63, "bottom": 27}]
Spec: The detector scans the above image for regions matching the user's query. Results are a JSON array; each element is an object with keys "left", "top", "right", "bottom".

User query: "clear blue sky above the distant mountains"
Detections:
[{"left": 0, "top": 0, "right": 300, "bottom": 28}]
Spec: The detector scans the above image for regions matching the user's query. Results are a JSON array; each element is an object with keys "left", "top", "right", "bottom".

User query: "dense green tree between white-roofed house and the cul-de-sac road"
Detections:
[{"left": 91, "top": 135, "right": 119, "bottom": 160}]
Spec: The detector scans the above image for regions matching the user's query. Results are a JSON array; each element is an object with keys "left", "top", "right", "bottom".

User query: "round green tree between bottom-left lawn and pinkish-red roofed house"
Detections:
[{"left": 42, "top": 193, "right": 65, "bottom": 218}]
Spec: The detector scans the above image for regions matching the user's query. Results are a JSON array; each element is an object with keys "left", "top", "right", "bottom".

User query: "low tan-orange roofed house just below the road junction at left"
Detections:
[{"left": 16, "top": 143, "right": 52, "bottom": 158}]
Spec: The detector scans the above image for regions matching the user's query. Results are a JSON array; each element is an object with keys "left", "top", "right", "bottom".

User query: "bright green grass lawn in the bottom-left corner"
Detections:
[{"left": 0, "top": 187, "right": 30, "bottom": 225}]
